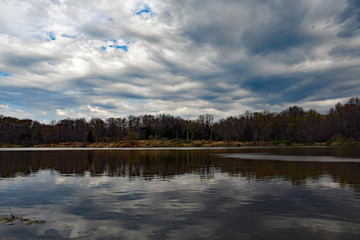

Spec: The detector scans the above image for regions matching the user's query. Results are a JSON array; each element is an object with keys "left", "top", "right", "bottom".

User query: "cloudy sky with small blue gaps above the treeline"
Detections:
[{"left": 0, "top": 0, "right": 360, "bottom": 122}]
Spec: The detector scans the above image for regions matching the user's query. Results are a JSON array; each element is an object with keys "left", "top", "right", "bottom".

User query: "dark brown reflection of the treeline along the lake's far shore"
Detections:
[{"left": 0, "top": 147, "right": 360, "bottom": 189}]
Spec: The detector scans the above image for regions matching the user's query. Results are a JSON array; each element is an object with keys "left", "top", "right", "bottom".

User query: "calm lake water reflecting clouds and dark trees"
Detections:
[{"left": 0, "top": 147, "right": 360, "bottom": 239}]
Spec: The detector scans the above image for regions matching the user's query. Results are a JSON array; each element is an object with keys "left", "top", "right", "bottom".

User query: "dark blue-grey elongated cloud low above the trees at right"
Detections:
[{"left": 242, "top": 64, "right": 360, "bottom": 105}]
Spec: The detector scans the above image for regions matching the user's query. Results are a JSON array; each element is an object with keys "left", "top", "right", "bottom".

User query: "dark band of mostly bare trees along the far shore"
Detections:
[{"left": 0, "top": 97, "right": 360, "bottom": 146}]
